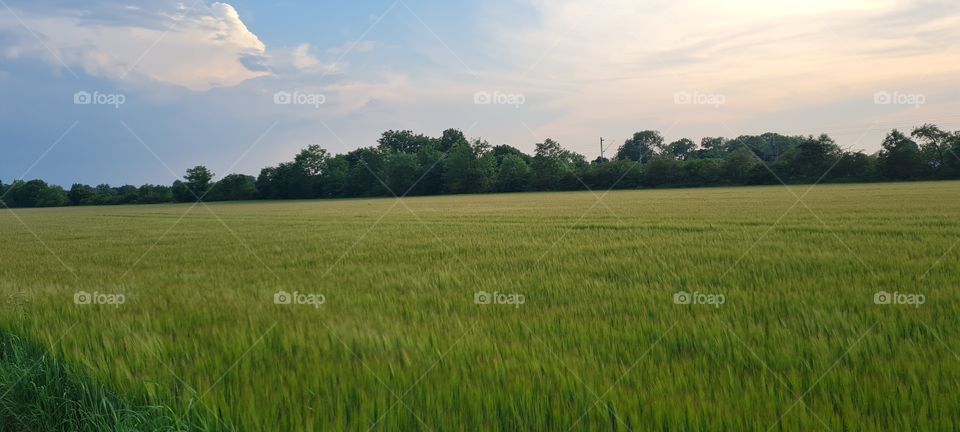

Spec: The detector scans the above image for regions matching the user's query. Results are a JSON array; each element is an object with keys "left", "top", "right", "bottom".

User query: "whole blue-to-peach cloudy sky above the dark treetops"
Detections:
[{"left": 0, "top": 0, "right": 960, "bottom": 187}]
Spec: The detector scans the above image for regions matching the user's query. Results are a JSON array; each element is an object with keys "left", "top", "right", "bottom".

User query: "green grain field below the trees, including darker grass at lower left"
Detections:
[{"left": 0, "top": 182, "right": 960, "bottom": 431}]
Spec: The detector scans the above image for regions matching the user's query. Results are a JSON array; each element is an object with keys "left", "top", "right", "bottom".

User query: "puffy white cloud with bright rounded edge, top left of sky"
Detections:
[{"left": 0, "top": 2, "right": 269, "bottom": 91}]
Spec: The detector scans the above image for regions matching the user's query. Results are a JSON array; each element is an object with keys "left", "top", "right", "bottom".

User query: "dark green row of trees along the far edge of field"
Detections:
[{"left": 0, "top": 124, "right": 960, "bottom": 207}]
